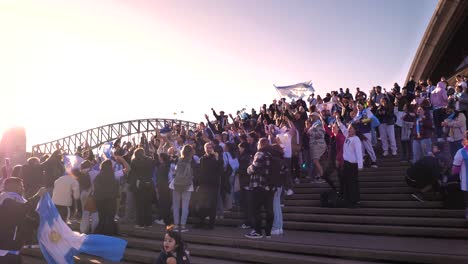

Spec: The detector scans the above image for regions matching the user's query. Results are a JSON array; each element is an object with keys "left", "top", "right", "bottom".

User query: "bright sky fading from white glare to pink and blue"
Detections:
[{"left": 0, "top": 0, "right": 437, "bottom": 149}]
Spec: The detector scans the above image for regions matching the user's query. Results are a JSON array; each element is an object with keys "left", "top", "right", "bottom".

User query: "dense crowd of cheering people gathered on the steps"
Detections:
[{"left": 0, "top": 76, "right": 468, "bottom": 262}]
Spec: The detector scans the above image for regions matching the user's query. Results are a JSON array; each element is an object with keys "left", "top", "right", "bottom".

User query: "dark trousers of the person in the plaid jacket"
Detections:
[{"left": 252, "top": 188, "right": 275, "bottom": 236}]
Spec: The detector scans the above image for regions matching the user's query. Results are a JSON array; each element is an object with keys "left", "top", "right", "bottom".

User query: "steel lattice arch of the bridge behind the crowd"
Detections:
[{"left": 31, "top": 118, "right": 197, "bottom": 156}]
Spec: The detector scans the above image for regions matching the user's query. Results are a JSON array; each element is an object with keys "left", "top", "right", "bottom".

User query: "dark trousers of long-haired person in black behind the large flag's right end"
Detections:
[{"left": 95, "top": 198, "right": 117, "bottom": 236}]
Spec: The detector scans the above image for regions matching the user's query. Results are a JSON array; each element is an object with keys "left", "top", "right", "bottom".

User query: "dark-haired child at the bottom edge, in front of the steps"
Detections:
[{"left": 154, "top": 226, "right": 190, "bottom": 264}]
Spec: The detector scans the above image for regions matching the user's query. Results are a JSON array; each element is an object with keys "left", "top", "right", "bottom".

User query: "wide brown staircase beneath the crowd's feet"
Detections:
[{"left": 24, "top": 157, "right": 468, "bottom": 264}]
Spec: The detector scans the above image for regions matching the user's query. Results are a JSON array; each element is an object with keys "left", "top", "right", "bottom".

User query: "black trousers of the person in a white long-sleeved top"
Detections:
[{"left": 342, "top": 161, "right": 360, "bottom": 206}]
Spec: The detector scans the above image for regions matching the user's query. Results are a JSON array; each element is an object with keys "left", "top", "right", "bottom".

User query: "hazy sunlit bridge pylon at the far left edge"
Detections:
[{"left": 0, "top": 127, "right": 26, "bottom": 165}]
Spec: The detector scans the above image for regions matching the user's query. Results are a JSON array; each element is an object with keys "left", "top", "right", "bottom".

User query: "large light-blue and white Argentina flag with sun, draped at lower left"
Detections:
[{"left": 36, "top": 193, "right": 127, "bottom": 264}]
